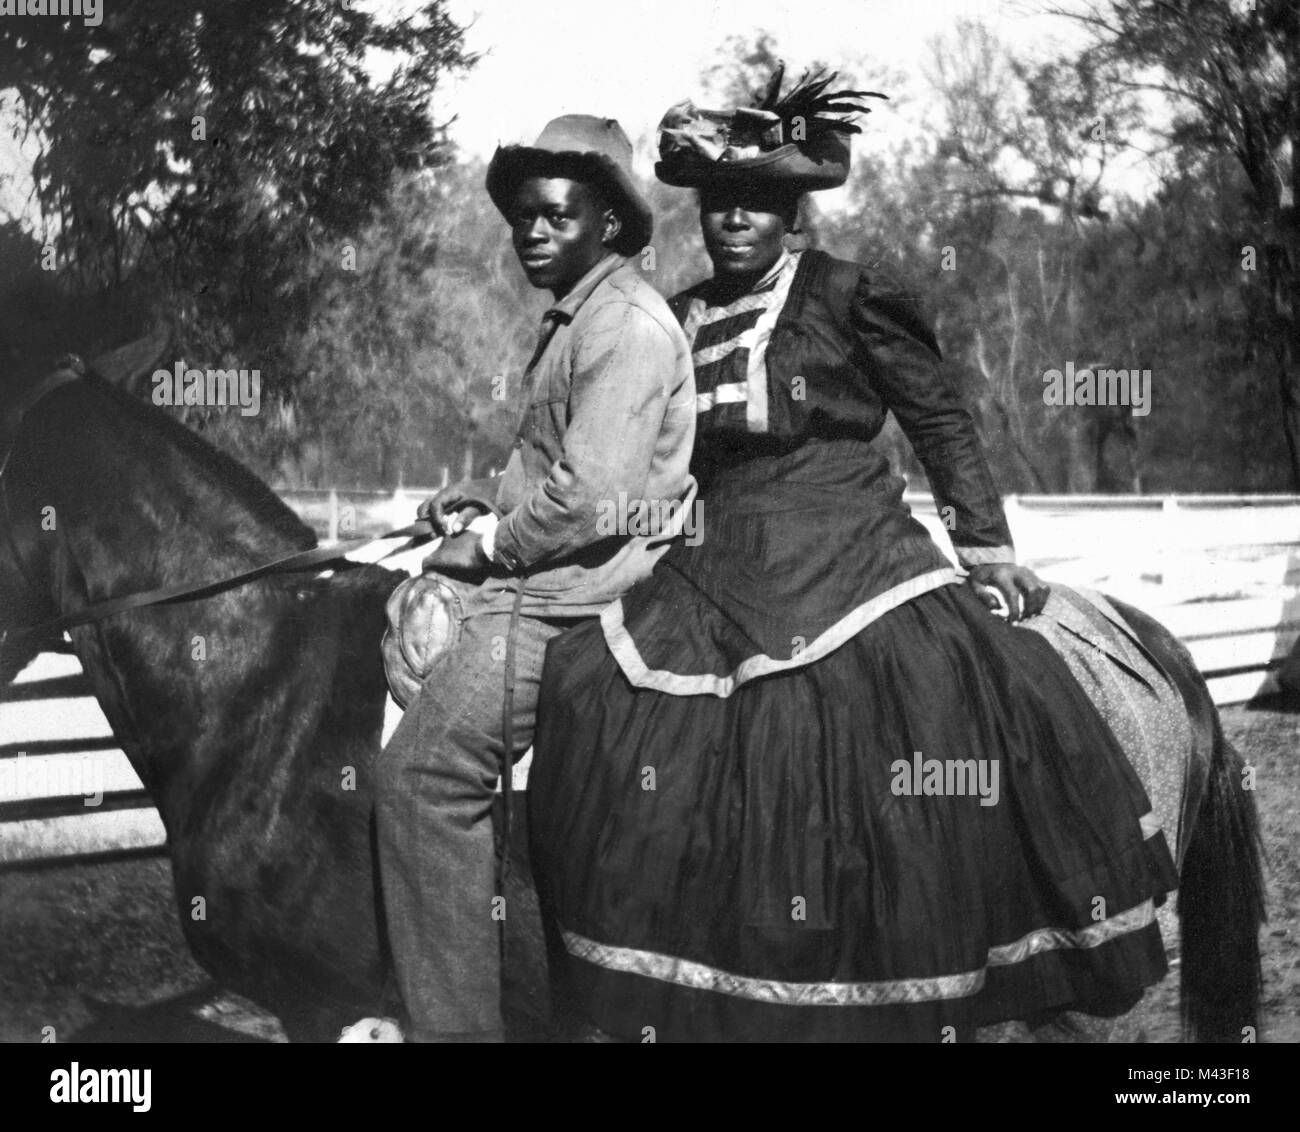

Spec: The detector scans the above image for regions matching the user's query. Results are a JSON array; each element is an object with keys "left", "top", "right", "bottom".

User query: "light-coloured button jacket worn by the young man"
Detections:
[{"left": 493, "top": 253, "right": 696, "bottom": 616}]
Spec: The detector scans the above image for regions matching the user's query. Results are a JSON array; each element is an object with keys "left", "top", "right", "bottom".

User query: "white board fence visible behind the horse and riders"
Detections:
[{"left": 0, "top": 489, "right": 1300, "bottom": 866}]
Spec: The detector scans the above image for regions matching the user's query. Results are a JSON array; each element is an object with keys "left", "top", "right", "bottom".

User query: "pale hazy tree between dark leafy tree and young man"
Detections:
[{"left": 274, "top": 161, "right": 535, "bottom": 487}]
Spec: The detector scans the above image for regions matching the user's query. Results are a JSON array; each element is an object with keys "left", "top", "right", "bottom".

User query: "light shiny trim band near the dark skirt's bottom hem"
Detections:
[{"left": 562, "top": 899, "right": 1156, "bottom": 1006}]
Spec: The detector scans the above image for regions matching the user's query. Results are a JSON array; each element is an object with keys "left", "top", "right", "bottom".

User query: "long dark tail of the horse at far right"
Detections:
[{"left": 1178, "top": 710, "right": 1265, "bottom": 1042}]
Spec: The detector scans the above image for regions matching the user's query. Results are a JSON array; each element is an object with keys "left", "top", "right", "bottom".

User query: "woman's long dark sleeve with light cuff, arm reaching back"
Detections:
[{"left": 849, "top": 270, "right": 1015, "bottom": 569}]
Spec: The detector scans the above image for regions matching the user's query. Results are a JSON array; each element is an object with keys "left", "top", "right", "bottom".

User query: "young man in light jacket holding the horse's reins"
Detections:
[{"left": 376, "top": 114, "right": 696, "bottom": 1041}]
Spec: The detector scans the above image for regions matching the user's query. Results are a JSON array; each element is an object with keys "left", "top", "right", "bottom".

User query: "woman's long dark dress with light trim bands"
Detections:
[{"left": 529, "top": 251, "right": 1177, "bottom": 1041}]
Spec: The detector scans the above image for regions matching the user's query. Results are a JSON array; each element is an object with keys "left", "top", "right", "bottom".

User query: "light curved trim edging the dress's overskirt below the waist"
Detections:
[{"left": 601, "top": 567, "right": 961, "bottom": 699}]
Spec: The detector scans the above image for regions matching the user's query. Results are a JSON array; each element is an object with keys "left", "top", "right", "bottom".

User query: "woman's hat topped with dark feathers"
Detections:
[{"left": 654, "top": 64, "right": 888, "bottom": 192}]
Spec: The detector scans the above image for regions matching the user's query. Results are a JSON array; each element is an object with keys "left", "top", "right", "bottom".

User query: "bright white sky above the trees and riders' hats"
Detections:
[{"left": 0, "top": 0, "right": 1149, "bottom": 230}]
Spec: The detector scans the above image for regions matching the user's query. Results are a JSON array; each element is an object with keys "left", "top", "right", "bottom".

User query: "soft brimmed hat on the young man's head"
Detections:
[{"left": 488, "top": 114, "right": 654, "bottom": 256}]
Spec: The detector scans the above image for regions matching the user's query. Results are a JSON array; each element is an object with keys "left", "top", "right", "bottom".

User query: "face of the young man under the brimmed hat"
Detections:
[{"left": 510, "top": 177, "right": 618, "bottom": 299}]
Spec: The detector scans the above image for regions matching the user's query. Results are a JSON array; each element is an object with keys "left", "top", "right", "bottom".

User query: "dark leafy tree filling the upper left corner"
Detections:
[{"left": 0, "top": 0, "right": 473, "bottom": 395}]
